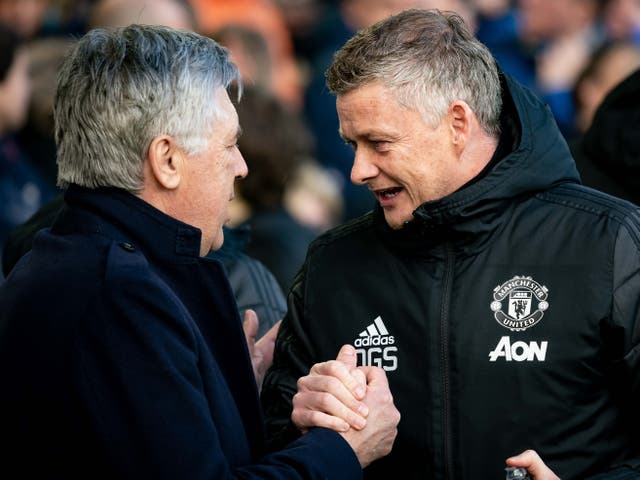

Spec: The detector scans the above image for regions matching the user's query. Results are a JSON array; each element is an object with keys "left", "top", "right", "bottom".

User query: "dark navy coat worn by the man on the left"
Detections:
[{"left": 0, "top": 186, "right": 361, "bottom": 480}]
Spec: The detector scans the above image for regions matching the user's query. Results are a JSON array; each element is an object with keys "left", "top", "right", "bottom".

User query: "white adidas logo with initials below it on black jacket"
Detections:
[{"left": 353, "top": 316, "right": 398, "bottom": 372}]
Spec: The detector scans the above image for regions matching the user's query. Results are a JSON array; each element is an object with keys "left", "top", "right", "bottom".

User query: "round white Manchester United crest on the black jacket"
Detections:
[{"left": 491, "top": 275, "right": 549, "bottom": 331}]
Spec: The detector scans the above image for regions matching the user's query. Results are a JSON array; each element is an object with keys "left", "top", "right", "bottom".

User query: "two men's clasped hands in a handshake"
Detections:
[{"left": 291, "top": 345, "right": 400, "bottom": 468}]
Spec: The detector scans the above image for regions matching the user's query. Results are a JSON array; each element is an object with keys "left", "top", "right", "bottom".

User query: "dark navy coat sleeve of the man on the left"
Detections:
[{"left": 74, "top": 249, "right": 362, "bottom": 480}]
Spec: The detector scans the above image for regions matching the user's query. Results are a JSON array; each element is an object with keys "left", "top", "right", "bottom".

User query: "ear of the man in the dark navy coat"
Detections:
[{"left": 147, "top": 135, "right": 184, "bottom": 190}]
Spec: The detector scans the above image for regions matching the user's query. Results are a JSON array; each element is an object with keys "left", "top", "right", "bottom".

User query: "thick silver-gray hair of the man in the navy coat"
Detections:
[{"left": 54, "top": 25, "right": 240, "bottom": 193}]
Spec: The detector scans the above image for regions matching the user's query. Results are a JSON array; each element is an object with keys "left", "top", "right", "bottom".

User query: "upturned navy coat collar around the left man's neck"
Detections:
[{"left": 58, "top": 185, "right": 202, "bottom": 263}]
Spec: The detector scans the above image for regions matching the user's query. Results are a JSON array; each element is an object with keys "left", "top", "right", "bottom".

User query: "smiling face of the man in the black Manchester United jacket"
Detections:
[{"left": 336, "top": 82, "right": 469, "bottom": 229}]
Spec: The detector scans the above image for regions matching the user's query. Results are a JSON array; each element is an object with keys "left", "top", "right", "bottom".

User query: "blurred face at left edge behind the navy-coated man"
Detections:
[{"left": 0, "top": 48, "right": 31, "bottom": 132}]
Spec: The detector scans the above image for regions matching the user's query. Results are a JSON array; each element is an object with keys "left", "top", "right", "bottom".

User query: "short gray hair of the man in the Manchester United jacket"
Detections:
[{"left": 327, "top": 9, "right": 502, "bottom": 136}]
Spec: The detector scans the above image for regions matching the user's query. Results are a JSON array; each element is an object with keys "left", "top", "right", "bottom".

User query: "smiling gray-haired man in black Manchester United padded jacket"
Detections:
[{"left": 262, "top": 10, "right": 640, "bottom": 480}]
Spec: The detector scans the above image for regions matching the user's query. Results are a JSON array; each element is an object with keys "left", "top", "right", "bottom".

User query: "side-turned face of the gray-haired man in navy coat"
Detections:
[{"left": 178, "top": 88, "right": 247, "bottom": 256}]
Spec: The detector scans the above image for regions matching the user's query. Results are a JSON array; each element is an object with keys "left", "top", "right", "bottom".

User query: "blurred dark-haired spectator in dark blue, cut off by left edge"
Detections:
[{"left": 0, "top": 26, "right": 53, "bottom": 276}]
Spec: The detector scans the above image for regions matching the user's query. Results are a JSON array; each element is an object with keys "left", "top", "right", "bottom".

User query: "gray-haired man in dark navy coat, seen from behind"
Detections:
[{"left": 0, "top": 25, "right": 399, "bottom": 480}]
